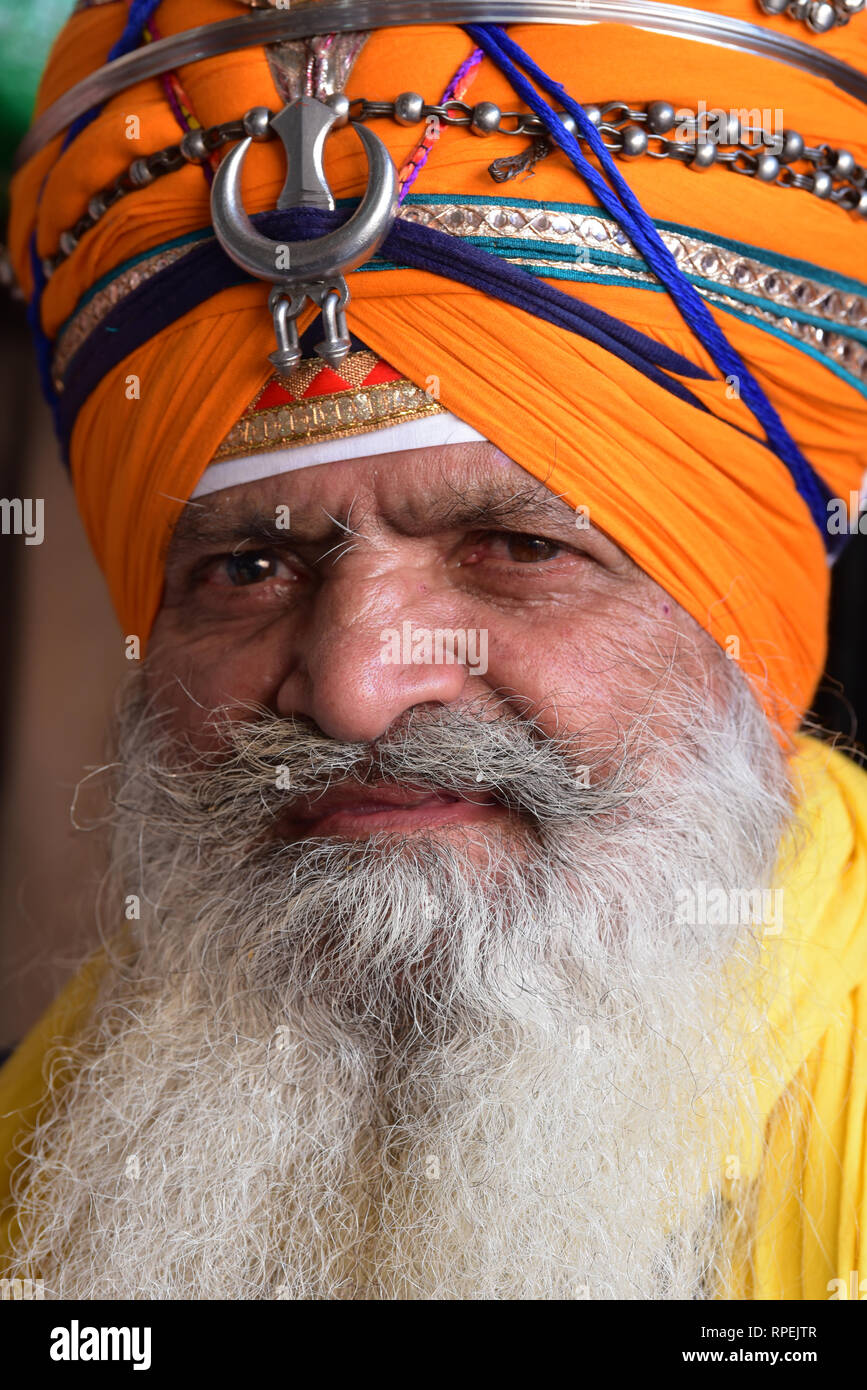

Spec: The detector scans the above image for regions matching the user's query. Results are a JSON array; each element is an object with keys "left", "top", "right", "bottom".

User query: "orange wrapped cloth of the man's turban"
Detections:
[{"left": 11, "top": 0, "right": 867, "bottom": 730}]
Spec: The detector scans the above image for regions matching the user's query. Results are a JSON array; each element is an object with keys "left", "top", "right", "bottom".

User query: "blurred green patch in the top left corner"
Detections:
[{"left": 0, "top": 0, "right": 72, "bottom": 200}]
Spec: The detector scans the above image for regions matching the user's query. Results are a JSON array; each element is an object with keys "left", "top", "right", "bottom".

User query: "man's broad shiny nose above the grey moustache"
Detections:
[{"left": 276, "top": 569, "right": 475, "bottom": 742}]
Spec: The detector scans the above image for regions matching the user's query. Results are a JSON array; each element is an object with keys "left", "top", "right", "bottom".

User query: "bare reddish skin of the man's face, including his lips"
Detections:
[{"left": 147, "top": 439, "right": 718, "bottom": 835}]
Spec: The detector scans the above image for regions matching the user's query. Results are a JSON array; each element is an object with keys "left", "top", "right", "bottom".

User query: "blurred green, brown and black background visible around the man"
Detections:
[{"left": 0, "top": 0, "right": 867, "bottom": 1056}]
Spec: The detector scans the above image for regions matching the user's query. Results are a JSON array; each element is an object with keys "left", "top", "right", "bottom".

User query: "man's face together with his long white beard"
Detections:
[{"left": 6, "top": 446, "right": 789, "bottom": 1298}]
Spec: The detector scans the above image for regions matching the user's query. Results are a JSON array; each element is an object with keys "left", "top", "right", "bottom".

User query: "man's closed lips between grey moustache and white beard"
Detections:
[{"left": 281, "top": 784, "right": 503, "bottom": 840}]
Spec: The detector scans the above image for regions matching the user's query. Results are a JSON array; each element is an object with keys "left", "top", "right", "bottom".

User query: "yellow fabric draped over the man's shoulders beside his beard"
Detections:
[{"left": 0, "top": 735, "right": 867, "bottom": 1300}]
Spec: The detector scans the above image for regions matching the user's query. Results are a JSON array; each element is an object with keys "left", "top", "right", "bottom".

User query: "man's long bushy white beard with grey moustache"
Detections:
[{"left": 11, "top": 657, "right": 791, "bottom": 1300}]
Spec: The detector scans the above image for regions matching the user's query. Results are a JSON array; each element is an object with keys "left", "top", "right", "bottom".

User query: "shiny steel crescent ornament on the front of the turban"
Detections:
[{"left": 211, "top": 121, "right": 397, "bottom": 286}]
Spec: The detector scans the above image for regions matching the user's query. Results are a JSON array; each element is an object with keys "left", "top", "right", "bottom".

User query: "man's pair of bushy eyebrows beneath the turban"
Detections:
[{"left": 162, "top": 485, "right": 583, "bottom": 560}]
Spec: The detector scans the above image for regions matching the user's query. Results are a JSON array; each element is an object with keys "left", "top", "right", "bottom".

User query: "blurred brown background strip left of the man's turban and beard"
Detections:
[{"left": 0, "top": 303, "right": 129, "bottom": 1051}]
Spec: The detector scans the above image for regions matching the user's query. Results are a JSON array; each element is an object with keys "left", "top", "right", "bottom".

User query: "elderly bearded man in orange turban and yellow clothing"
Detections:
[{"left": 0, "top": 0, "right": 867, "bottom": 1300}]
